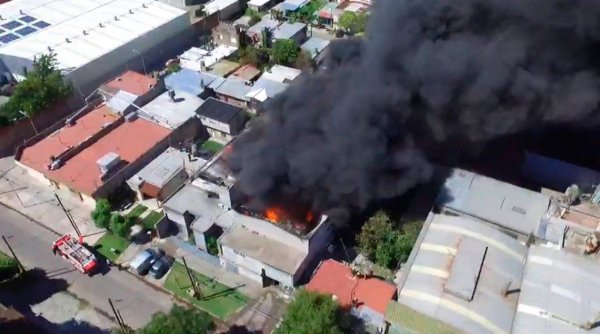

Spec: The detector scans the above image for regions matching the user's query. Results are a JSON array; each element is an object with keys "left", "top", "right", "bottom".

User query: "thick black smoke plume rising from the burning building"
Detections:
[{"left": 230, "top": 0, "right": 600, "bottom": 217}]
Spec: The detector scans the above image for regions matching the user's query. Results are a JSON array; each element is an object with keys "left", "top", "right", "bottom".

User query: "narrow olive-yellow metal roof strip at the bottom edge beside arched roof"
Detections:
[{"left": 385, "top": 301, "right": 462, "bottom": 334}]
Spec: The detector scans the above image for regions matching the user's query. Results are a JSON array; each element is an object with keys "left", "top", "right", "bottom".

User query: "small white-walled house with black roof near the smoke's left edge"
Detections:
[{"left": 196, "top": 97, "right": 246, "bottom": 143}]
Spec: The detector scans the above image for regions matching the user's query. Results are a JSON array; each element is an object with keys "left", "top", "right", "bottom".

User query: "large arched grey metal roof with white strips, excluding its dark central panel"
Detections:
[{"left": 398, "top": 215, "right": 527, "bottom": 334}]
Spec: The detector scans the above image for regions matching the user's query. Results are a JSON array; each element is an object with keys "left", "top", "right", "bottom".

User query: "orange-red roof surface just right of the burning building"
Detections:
[{"left": 306, "top": 260, "right": 396, "bottom": 314}]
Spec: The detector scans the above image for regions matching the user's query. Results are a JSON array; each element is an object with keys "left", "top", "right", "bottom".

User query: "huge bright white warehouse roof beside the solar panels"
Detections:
[{"left": 0, "top": 0, "right": 186, "bottom": 70}]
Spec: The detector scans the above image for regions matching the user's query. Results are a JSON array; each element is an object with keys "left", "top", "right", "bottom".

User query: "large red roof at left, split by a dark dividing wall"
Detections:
[{"left": 20, "top": 104, "right": 170, "bottom": 195}]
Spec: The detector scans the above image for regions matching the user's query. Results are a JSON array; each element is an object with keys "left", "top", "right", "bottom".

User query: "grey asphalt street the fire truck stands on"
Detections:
[{"left": 0, "top": 206, "right": 173, "bottom": 328}]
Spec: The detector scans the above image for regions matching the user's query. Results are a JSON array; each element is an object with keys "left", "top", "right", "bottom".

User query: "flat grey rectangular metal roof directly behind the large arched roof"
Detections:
[{"left": 438, "top": 169, "right": 550, "bottom": 235}]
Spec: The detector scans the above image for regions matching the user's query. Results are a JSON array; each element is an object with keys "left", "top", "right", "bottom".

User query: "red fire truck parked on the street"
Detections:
[{"left": 52, "top": 234, "right": 98, "bottom": 274}]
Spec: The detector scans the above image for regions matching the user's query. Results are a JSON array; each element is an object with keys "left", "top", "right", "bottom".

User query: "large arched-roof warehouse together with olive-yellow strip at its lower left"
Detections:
[{"left": 385, "top": 213, "right": 528, "bottom": 334}]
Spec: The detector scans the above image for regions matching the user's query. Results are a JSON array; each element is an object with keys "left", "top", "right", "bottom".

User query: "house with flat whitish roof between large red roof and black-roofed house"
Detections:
[{"left": 138, "top": 90, "right": 204, "bottom": 130}]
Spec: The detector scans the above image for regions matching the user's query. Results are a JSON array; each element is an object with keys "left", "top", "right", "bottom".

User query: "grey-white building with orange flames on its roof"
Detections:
[{"left": 163, "top": 155, "right": 333, "bottom": 288}]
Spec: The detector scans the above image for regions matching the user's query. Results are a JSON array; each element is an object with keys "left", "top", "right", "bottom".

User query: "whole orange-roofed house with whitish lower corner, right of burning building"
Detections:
[{"left": 305, "top": 259, "right": 396, "bottom": 327}]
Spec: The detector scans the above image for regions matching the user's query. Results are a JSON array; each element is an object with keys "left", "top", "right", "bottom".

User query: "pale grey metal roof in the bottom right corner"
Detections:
[{"left": 512, "top": 246, "right": 600, "bottom": 334}]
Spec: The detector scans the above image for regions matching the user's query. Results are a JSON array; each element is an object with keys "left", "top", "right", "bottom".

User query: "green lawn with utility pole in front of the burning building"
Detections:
[{"left": 165, "top": 262, "right": 248, "bottom": 320}]
